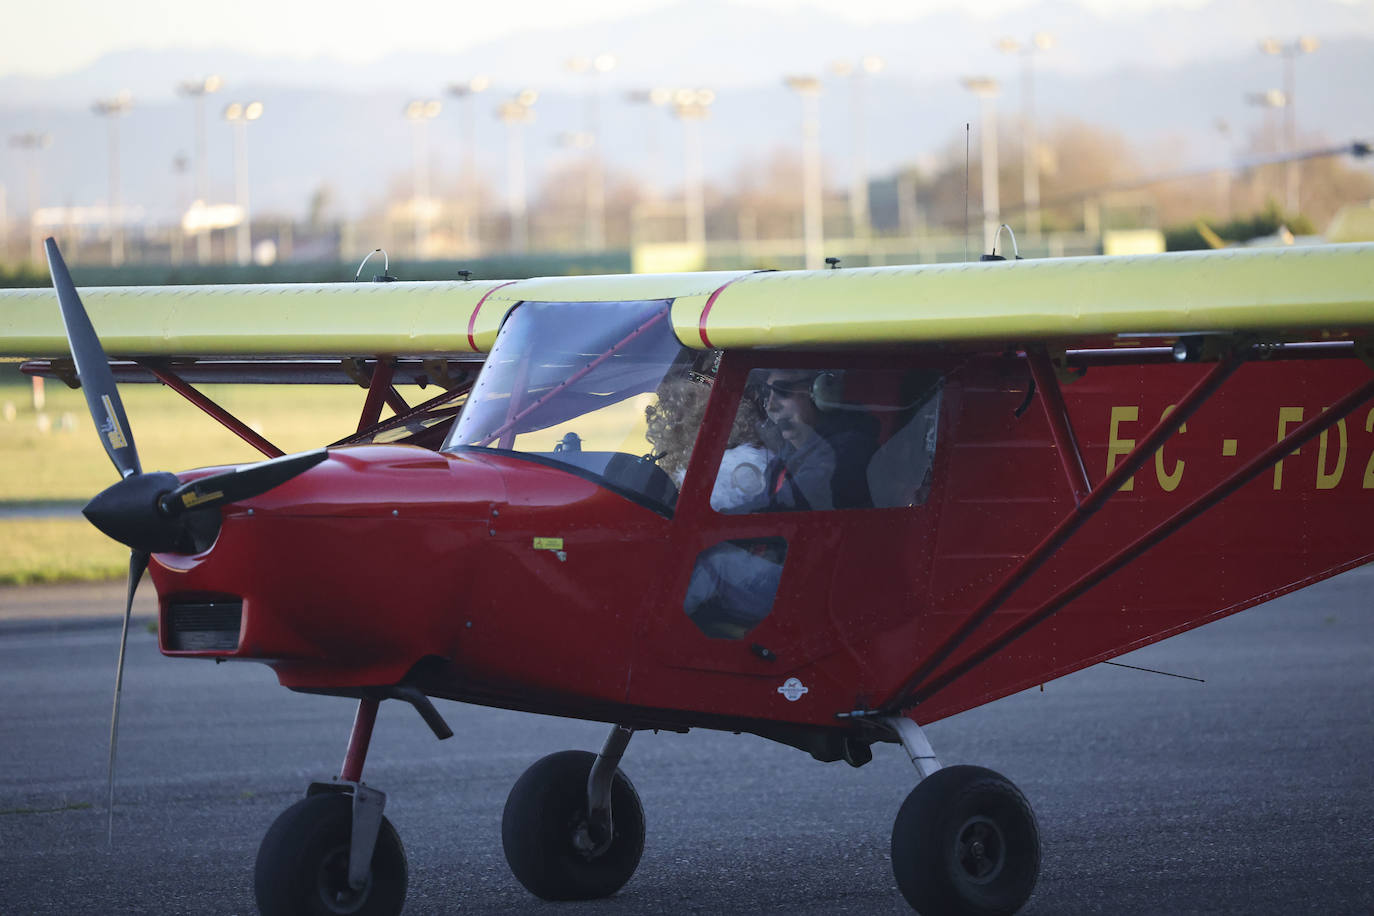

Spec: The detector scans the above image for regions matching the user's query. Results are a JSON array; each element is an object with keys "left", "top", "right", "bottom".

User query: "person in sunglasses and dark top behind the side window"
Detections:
[{"left": 756, "top": 369, "right": 878, "bottom": 511}]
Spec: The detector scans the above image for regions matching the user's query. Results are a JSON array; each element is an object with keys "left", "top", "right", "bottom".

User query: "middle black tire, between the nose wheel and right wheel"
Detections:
[{"left": 502, "top": 751, "right": 644, "bottom": 900}]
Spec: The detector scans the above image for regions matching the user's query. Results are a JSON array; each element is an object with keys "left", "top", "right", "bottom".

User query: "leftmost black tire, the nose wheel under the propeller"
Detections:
[{"left": 253, "top": 792, "right": 407, "bottom": 916}]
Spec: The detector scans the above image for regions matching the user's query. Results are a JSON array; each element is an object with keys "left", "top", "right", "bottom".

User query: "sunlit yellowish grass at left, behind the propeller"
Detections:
[{"left": 0, "top": 365, "right": 406, "bottom": 585}]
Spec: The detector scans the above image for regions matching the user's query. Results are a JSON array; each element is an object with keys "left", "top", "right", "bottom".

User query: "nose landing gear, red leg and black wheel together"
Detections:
[{"left": 253, "top": 698, "right": 408, "bottom": 916}]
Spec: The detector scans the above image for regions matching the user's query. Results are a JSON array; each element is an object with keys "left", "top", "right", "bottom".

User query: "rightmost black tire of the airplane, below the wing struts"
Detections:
[{"left": 892, "top": 766, "right": 1040, "bottom": 916}]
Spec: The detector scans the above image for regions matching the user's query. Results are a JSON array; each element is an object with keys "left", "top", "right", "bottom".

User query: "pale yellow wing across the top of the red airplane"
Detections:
[{"left": 0, "top": 244, "right": 1374, "bottom": 357}]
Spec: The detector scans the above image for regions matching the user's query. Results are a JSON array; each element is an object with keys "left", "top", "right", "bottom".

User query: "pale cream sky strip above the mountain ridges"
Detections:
[{"left": 8, "top": 0, "right": 1236, "bottom": 76}]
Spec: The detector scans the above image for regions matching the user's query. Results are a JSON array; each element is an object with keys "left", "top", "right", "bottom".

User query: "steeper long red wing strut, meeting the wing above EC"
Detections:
[{"left": 883, "top": 346, "right": 1250, "bottom": 711}]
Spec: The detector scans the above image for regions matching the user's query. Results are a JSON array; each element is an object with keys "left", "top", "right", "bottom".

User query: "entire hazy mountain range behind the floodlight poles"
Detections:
[{"left": 0, "top": 0, "right": 1374, "bottom": 217}]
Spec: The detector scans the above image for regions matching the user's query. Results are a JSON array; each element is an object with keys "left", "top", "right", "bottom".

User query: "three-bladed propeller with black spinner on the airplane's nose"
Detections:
[{"left": 44, "top": 238, "right": 327, "bottom": 845}]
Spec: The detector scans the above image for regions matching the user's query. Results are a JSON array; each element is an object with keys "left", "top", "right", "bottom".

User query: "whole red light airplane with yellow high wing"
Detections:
[{"left": 0, "top": 240, "right": 1374, "bottom": 913}]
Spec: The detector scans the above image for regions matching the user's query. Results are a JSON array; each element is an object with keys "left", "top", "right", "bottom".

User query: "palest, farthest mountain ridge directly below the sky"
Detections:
[{"left": 0, "top": 0, "right": 1374, "bottom": 107}]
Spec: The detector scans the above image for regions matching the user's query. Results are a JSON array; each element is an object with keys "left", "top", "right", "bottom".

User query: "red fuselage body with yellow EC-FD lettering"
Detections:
[{"left": 153, "top": 353, "right": 1374, "bottom": 747}]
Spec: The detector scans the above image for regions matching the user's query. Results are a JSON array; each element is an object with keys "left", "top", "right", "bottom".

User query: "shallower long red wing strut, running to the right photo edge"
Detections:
[{"left": 889, "top": 368, "right": 1374, "bottom": 709}]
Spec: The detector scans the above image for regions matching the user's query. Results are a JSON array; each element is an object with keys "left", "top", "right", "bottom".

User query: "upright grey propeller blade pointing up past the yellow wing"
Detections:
[{"left": 44, "top": 238, "right": 143, "bottom": 477}]
